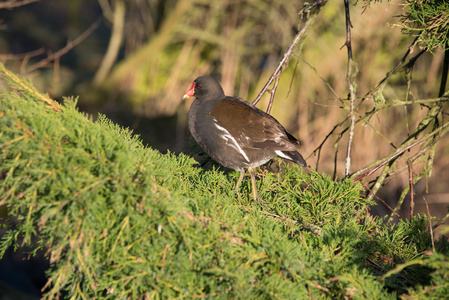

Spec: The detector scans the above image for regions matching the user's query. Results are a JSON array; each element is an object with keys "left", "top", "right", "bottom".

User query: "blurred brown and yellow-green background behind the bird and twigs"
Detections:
[{"left": 0, "top": 0, "right": 449, "bottom": 298}]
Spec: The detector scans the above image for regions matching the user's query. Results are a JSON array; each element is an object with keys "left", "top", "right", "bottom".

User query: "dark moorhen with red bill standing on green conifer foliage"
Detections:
[{"left": 182, "top": 75, "right": 307, "bottom": 201}]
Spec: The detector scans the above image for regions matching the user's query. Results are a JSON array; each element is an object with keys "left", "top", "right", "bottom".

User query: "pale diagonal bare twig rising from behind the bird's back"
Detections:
[{"left": 253, "top": 0, "right": 327, "bottom": 105}]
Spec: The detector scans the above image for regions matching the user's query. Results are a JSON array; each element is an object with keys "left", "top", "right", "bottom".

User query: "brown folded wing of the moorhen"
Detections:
[{"left": 210, "top": 97, "right": 299, "bottom": 151}]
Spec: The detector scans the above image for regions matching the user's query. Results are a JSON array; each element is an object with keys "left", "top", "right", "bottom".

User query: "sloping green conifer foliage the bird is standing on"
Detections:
[{"left": 0, "top": 67, "right": 449, "bottom": 299}]
